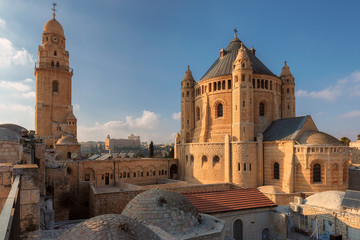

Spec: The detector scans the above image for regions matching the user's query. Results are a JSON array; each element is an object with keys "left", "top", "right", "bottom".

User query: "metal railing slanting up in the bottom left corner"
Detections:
[{"left": 0, "top": 175, "right": 20, "bottom": 240}]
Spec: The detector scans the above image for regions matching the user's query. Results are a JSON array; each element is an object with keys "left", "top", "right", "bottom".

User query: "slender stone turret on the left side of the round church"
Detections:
[{"left": 181, "top": 66, "right": 195, "bottom": 142}]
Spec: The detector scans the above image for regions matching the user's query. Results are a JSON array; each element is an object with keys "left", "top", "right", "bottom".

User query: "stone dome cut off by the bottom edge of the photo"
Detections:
[{"left": 58, "top": 214, "right": 160, "bottom": 240}]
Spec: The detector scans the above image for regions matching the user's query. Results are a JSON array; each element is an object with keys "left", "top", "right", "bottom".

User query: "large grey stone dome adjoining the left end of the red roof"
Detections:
[{"left": 121, "top": 188, "right": 200, "bottom": 233}]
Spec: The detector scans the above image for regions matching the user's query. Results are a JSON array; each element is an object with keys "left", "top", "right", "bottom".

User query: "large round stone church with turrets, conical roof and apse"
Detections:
[{"left": 175, "top": 33, "right": 349, "bottom": 197}]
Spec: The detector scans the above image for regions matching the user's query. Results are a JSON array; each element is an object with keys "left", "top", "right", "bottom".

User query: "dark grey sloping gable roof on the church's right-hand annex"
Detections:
[{"left": 263, "top": 115, "right": 310, "bottom": 141}]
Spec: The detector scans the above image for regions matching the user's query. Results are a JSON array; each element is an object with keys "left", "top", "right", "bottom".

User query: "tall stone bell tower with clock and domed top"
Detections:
[{"left": 35, "top": 9, "right": 77, "bottom": 148}]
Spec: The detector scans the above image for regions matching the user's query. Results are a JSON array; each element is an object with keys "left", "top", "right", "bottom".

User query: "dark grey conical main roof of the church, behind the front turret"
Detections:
[{"left": 201, "top": 37, "right": 275, "bottom": 80}]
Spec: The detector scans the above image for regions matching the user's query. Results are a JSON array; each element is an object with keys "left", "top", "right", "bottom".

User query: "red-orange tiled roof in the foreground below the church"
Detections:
[{"left": 183, "top": 188, "right": 276, "bottom": 213}]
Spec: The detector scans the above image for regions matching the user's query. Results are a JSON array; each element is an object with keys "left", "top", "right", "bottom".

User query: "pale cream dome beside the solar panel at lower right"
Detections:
[{"left": 303, "top": 191, "right": 345, "bottom": 210}]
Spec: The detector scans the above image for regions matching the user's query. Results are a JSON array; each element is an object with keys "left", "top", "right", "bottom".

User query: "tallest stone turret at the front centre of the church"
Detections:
[{"left": 232, "top": 42, "right": 254, "bottom": 141}]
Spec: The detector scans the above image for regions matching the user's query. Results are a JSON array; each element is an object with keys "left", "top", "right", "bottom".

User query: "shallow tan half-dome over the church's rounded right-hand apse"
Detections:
[{"left": 297, "top": 130, "right": 343, "bottom": 146}]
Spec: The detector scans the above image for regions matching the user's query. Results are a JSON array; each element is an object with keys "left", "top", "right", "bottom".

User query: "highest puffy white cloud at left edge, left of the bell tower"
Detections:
[{"left": 0, "top": 38, "right": 34, "bottom": 68}]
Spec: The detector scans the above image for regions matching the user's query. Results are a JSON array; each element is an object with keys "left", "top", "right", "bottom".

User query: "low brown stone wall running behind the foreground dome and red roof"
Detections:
[{"left": 90, "top": 183, "right": 238, "bottom": 217}]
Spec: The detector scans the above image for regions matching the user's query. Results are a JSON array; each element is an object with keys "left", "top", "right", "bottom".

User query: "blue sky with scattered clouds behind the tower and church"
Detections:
[{"left": 0, "top": 0, "right": 360, "bottom": 143}]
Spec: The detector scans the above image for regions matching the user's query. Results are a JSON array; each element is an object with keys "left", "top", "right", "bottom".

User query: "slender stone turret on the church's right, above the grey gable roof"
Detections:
[{"left": 280, "top": 61, "right": 296, "bottom": 118}]
